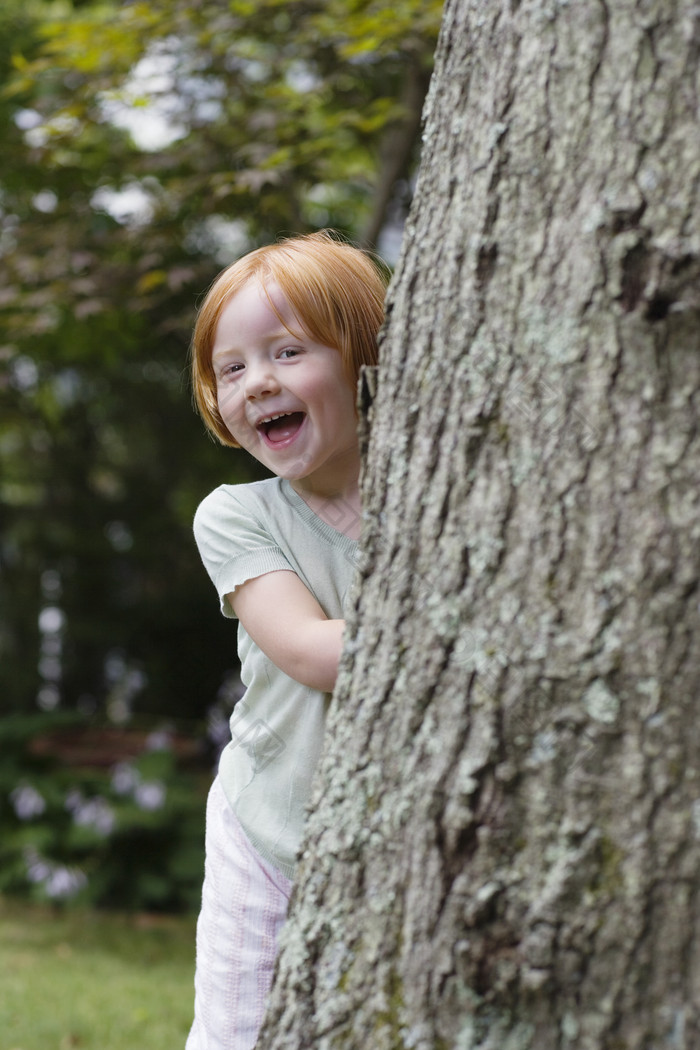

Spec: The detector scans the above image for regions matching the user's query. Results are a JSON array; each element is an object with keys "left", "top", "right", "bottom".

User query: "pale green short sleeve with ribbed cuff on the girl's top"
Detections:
[{"left": 194, "top": 485, "right": 294, "bottom": 618}]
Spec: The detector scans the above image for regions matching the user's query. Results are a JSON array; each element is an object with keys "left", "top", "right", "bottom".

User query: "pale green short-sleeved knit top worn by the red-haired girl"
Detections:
[{"left": 194, "top": 478, "right": 357, "bottom": 878}]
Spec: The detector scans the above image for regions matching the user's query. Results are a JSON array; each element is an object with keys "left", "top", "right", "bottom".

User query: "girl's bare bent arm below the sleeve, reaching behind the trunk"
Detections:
[{"left": 228, "top": 569, "right": 345, "bottom": 693}]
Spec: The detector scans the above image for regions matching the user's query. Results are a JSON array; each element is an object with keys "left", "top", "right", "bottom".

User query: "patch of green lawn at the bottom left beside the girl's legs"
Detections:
[{"left": 0, "top": 898, "right": 195, "bottom": 1050}]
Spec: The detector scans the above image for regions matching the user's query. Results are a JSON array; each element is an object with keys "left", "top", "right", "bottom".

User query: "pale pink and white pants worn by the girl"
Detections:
[{"left": 186, "top": 778, "right": 292, "bottom": 1050}]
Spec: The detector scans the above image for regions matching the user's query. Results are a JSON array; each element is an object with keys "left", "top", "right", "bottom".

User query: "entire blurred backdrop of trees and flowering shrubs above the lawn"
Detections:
[{"left": 0, "top": 0, "right": 441, "bottom": 911}]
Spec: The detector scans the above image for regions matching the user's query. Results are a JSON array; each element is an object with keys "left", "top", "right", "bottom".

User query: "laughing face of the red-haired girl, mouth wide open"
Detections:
[{"left": 212, "top": 278, "right": 359, "bottom": 497}]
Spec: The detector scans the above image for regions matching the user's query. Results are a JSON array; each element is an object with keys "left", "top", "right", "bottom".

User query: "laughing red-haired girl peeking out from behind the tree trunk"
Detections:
[{"left": 187, "top": 232, "right": 385, "bottom": 1050}]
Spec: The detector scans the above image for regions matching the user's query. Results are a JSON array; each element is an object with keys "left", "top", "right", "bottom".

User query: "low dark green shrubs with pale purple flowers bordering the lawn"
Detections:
[{"left": 0, "top": 715, "right": 210, "bottom": 911}]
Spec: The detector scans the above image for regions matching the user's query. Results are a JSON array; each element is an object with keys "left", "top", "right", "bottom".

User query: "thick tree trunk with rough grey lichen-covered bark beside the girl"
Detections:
[{"left": 260, "top": 0, "right": 700, "bottom": 1050}]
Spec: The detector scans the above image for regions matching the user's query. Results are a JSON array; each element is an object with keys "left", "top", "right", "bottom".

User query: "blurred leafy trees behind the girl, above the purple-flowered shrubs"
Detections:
[{"left": 0, "top": 0, "right": 440, "bottom": 717}]
